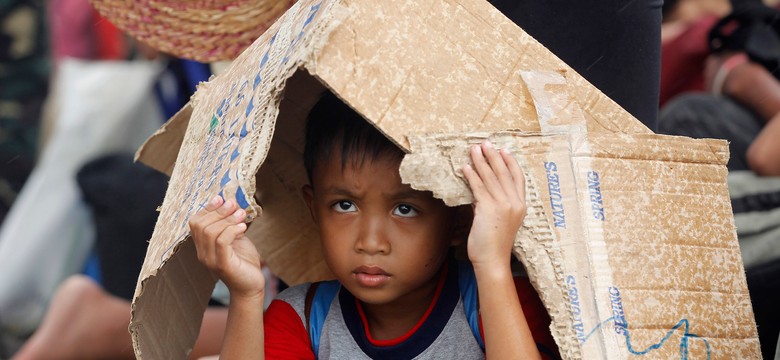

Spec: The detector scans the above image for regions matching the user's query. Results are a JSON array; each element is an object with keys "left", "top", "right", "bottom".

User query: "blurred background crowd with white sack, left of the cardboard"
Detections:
[{"left": 0, "top": 0, "right": 225, "bottom": 359}]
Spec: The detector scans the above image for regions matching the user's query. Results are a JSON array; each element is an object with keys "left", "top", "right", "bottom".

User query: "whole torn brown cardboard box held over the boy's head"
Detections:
[{"left": 130, "top": 0, "right": 760, "bottom": 359}]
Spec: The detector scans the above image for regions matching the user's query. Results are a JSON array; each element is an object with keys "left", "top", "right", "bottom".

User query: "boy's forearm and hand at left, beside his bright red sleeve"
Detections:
[{"left": 189, "top": 196, "right": 265, "bottom": 359}]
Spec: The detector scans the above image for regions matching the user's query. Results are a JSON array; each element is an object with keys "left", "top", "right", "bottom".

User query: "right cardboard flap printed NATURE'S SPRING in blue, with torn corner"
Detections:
[{"left": 401, "top": 133, "right": 760, "bottom": 359}]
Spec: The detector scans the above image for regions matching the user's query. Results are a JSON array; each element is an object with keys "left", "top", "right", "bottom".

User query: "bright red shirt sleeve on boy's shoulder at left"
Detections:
[{"left": 263, "top": 300, "right": 315, "bottom": 360}]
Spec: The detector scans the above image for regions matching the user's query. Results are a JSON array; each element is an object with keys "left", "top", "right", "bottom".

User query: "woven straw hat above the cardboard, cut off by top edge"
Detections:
[{"left": 92, "top": 0, "right": 295, "bottom": 62}]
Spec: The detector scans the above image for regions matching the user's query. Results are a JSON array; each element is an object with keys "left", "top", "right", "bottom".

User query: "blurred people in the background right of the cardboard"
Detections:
[{"left": 658, "top": 0, "right": 780, "bottom": 358}]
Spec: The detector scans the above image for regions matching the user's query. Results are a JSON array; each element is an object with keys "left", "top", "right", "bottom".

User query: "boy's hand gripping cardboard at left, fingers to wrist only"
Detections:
[{"left": 189, "top": 196, "right": 265, "bottom": 299}]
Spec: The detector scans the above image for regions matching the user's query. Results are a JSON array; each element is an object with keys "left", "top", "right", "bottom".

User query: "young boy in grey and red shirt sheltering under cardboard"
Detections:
[{"left": 190, "top": 94, "right": 554, "bottom": 359}]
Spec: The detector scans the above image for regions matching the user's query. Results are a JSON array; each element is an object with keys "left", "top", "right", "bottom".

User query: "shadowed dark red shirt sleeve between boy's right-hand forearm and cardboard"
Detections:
[{"left": 515, "top": 276, "right": 561, "bottom": 359}]
